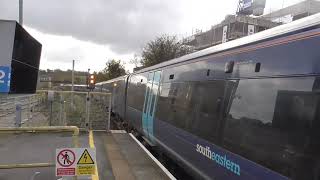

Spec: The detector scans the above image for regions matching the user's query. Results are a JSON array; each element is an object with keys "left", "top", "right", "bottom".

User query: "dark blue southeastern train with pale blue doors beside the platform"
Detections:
[{"left": 96, "top": 14, "right": 320, "bottom": 180}]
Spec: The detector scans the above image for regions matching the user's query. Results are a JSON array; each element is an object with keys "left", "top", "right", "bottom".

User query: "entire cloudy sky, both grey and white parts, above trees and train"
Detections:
[{"left": 0, "top": 0, "right": 301, "bottom": 72}]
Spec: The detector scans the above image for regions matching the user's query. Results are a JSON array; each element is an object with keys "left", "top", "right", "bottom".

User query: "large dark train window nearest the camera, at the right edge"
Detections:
[{"left": 223, "top": 77, "right": 320, "bottom": 180}]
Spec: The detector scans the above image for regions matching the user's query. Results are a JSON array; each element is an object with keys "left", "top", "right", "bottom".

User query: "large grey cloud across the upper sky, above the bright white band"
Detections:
[{"left": 0, "top": 0, "right": 183, "bottom": 53}]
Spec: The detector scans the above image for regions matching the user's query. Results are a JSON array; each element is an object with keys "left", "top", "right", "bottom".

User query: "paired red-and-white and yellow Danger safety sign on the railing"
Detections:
[{"left": 56, "top": 148, "right": 96, "bottom": 176}]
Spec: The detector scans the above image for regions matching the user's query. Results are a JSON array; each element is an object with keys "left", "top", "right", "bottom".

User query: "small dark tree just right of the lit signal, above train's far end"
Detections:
[{"left": 95, "top": 59, "right": 126, "bottom": 82}]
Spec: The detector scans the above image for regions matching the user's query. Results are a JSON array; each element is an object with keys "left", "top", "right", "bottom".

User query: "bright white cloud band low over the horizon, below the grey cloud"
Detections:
[{"left": 26, "top": 27, "right": 133, "bottom": 71}]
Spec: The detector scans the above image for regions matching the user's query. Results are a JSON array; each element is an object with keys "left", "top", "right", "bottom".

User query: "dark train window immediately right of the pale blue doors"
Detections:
[{"left": 156, "top": 81, "right": 224, "bottom": 142}]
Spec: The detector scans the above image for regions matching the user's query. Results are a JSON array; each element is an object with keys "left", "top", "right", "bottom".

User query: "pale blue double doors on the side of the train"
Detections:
[{"left": 142, "top": 71, "right": 161, "bottom": 139}]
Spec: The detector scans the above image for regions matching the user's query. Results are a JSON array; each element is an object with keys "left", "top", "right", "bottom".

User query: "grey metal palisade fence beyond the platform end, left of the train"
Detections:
[{"left": 0, "top": 91, "right": 111, "bottom": 130}]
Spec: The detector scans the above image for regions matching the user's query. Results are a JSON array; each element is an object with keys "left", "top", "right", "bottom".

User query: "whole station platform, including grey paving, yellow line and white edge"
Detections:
[{"left": 0, "top": 131, "right": 174, "bottom": 180}]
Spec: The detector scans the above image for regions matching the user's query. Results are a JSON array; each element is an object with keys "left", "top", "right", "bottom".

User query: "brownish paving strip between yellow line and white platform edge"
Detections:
[{"left": 105, "top": 133, "right": 169, "bottom": 180}]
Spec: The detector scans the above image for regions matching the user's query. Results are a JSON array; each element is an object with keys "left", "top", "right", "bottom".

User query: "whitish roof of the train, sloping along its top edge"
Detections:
[{"left": 132, "top": 13, "right": 320, "bottom": 74}]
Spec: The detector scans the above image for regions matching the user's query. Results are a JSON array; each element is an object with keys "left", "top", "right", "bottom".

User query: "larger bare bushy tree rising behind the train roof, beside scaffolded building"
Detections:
[{"left": 141, "top": 35, "right": 192, "bottom": 67}]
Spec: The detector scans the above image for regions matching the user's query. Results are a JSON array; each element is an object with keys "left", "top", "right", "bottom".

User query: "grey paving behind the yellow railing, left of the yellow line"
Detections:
[{"left": 0, "top": 132, "right": 89, "bottom": 180}]
